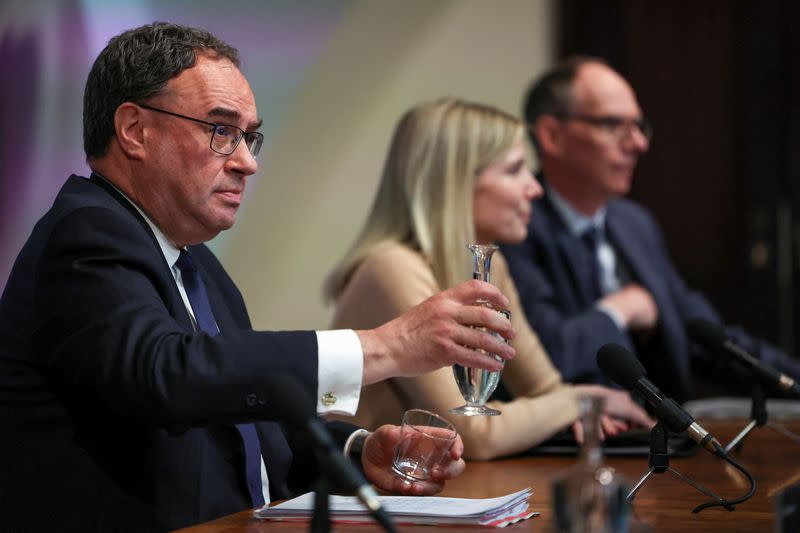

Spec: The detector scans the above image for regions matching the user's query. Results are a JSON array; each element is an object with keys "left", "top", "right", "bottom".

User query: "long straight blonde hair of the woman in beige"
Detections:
[{"left": 324, "top": 98, "right": 525, "bottom": 301}]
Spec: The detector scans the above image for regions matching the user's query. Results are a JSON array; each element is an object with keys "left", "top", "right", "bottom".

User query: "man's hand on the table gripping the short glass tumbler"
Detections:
[{"left": 361, "top": 425, "right": 466, "bottom": 496}]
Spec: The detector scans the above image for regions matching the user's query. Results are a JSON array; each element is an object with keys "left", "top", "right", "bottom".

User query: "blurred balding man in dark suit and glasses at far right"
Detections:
[{"left": 503, "top": 57, "right": 800, "bottom": 400}]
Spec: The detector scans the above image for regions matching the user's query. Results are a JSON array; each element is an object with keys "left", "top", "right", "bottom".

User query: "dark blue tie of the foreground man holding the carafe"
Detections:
[{"left": 175, "top": 250, "right": 264, "bottom": 507}]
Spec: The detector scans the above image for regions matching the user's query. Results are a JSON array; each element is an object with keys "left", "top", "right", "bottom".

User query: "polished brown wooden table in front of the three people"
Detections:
[{"left": 181, "top": 420, "right": 800, "bottom": 533}]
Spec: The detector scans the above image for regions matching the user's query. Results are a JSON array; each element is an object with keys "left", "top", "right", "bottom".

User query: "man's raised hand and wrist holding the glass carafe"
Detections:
[{"left": 356, "top": 280, "right": 515, "bottom": 385}]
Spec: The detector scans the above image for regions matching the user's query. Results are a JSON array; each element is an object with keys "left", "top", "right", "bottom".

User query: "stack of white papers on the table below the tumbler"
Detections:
[{"left": 254, "top": 487, "right": 539, "bottom": 527}]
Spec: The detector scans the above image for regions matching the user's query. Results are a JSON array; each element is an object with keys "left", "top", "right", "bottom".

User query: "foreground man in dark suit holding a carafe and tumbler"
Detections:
[{"left": 0, "top": 23, "right": 513, "bottom": 531}]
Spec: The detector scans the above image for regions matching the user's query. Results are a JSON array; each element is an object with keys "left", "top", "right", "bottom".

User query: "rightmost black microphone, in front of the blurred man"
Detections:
[{"left": 686, "top": 318, "right": 800, "bottom": 396}]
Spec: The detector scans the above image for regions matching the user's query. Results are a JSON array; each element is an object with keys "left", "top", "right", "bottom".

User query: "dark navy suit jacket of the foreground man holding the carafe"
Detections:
[{"left": 0, "top": 176, "right": 350, "bottom": 531}]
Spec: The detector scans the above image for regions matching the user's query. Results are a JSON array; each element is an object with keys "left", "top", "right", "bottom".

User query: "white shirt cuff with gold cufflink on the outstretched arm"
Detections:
[{"left": 316, "top": 329, "right": 364, "bottom": 416}]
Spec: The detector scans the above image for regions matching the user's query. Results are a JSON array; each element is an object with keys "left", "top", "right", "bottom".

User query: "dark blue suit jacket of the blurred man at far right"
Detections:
[{"left": 502, "top": 196, "right": 800, "bottom": 400}]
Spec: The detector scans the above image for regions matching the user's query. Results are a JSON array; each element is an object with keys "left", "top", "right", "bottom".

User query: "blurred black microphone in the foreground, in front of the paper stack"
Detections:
[{"left": 267, "top": 373, "right": 396, "bottom": 532}]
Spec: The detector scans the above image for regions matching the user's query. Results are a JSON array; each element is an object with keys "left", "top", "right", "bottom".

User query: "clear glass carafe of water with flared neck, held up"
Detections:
[{"left": 450, "top": 244, "right": 511, "bottom": 416}]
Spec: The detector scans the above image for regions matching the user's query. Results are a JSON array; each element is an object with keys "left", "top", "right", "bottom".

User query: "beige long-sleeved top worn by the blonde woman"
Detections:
[{"left": 332, "top": 243, "right": 579, "bottom": 459}]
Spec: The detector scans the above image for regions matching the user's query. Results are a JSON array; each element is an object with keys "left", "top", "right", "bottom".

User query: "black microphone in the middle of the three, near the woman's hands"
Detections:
[{"left": 597, "top": 343, "right": 725, "bottom": 457}]
